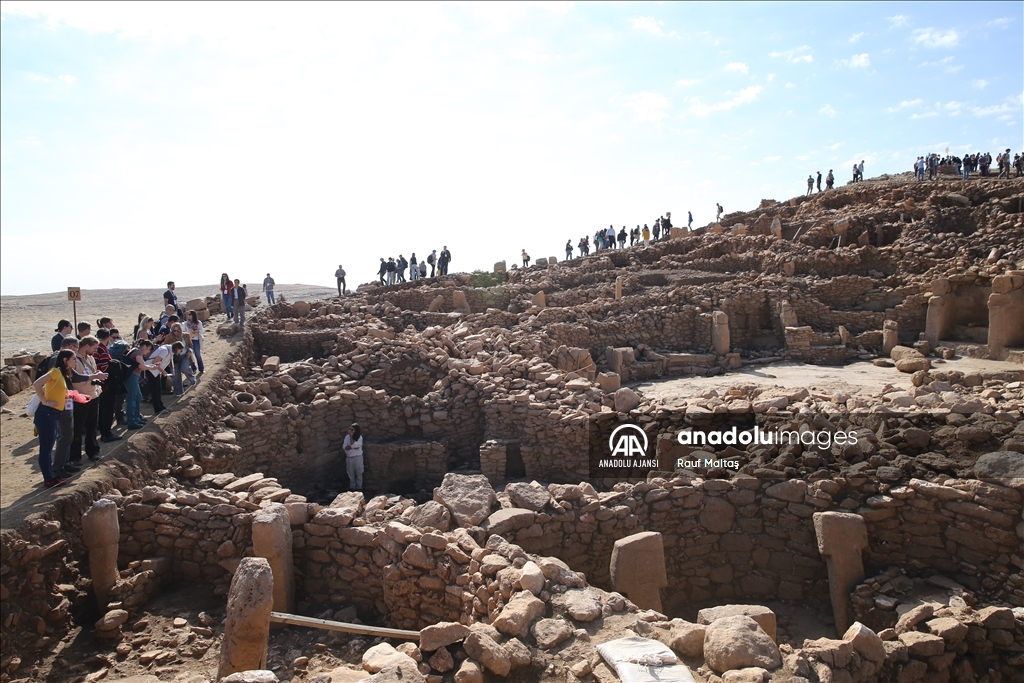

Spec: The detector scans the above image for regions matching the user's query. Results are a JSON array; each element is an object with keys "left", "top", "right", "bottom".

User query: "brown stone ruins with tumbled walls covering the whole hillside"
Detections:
[{"left": 0, "top": 178, "right": 1024, "bottom": 683}]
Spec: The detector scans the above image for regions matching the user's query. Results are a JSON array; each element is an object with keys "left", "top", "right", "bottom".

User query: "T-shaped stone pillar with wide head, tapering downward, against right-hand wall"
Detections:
[{"left": 814, "top": 512, "right": 867, "bottom": 637}]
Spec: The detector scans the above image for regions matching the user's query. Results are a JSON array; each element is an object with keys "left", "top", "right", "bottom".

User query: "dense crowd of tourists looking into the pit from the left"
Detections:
[{"left": 29, "top": 274, "right": 205, "bottom": 487}]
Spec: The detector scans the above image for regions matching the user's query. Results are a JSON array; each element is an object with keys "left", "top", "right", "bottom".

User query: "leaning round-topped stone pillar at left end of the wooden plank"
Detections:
[{"left": 217, "top": 557, "right": 273, "bottom": 680}]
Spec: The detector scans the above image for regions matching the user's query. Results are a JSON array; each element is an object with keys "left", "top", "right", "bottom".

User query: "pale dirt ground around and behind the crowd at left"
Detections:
[{"left": 0, "top": 285, "right": 336, "bottom": 528}]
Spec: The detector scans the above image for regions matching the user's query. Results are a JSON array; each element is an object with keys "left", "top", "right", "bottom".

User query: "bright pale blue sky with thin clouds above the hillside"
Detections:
[{"left": 0, "top": 2, "right": 1024, "bottom": 295}]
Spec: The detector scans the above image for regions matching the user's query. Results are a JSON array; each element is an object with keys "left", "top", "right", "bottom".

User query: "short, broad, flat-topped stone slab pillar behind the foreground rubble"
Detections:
[{"left": 610, "top": 531, "right": 669, "bottom": 611}]
